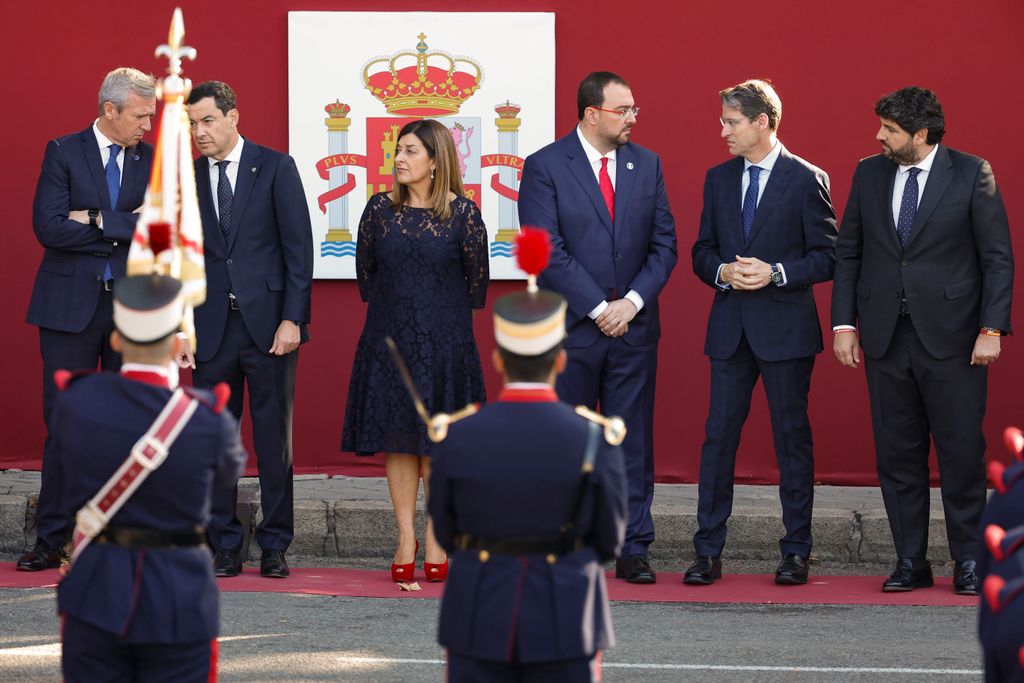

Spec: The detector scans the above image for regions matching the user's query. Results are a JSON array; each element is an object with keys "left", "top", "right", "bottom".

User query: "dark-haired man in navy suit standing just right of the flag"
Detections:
[{"left": 179, "top": 81, "right": 313, "bottom": 579}]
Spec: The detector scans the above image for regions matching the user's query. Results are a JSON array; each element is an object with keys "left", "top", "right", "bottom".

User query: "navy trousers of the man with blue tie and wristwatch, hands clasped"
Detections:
[{"left": 693, "top": 335, "right": 814, "bottom": 559}]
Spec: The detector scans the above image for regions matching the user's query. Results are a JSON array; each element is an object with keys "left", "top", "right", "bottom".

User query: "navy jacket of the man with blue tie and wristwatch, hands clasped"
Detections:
[{"left": 692, "top": 142, "right": 836, "bottom": 360}]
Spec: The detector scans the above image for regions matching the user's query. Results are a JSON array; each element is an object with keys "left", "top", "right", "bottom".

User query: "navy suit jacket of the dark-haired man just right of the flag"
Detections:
[{"left": 196, "top": 139, "right": 313, "bottom": 361}]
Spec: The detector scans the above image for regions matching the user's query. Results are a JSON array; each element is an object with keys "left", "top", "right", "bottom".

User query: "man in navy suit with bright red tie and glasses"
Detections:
[{"left": 519, "top": 72, "right": 677, "bottom": 584}]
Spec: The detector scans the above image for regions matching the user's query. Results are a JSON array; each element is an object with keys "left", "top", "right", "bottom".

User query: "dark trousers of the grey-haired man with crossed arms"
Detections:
[{"left": 36, "top": 291, "right": 121, "bottom": 548}]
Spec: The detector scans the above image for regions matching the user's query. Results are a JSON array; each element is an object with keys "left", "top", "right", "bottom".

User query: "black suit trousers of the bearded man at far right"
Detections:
[{"left": 865, "top": 316, "right": 988, "bottom": 564}]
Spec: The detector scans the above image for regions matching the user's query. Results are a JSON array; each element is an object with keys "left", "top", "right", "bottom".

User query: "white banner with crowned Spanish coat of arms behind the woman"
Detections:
[{"left": 288, "top": 12, "right": 555, "bottom": 280}]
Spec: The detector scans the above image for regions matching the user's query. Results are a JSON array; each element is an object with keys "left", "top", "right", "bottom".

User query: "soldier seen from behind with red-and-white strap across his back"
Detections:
[{"left": 51, "top": 275, "right": 246, "bottom": 683}]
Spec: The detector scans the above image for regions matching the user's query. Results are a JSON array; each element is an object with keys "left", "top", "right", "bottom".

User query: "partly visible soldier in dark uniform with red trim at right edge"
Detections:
[{"left": 978, "top": 436, "right": 1024, "bottom": 683}]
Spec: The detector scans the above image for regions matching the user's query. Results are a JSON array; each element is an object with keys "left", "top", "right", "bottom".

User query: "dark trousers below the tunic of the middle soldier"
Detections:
[{"left": 447, "top": 652, "right": 601, "bottom": 683}]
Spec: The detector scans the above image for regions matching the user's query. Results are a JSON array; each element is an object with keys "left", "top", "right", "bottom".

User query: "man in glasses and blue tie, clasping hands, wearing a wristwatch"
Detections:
[{"left": 683, "top": 80, "right": 836, "bottom": 586}]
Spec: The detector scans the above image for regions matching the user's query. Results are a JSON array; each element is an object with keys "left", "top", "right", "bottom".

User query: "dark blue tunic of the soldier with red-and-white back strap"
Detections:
[{"left": 51, "top": 373, "right": 246, "bottom": 643}]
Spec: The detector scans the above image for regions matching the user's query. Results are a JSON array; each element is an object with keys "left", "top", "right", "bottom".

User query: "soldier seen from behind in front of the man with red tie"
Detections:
[{"left": 428, "top": 272, "right": 627, "bottom": 683}]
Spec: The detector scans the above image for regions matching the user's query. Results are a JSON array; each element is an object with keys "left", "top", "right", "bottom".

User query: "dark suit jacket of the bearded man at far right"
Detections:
[{"left": 831, "top": 144, "right": 1014, "bottom": 358}]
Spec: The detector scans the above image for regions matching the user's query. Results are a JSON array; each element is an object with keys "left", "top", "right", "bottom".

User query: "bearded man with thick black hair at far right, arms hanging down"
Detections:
[{"left": 831, "top": 87, "right": 1014, "bottom": 595}]
